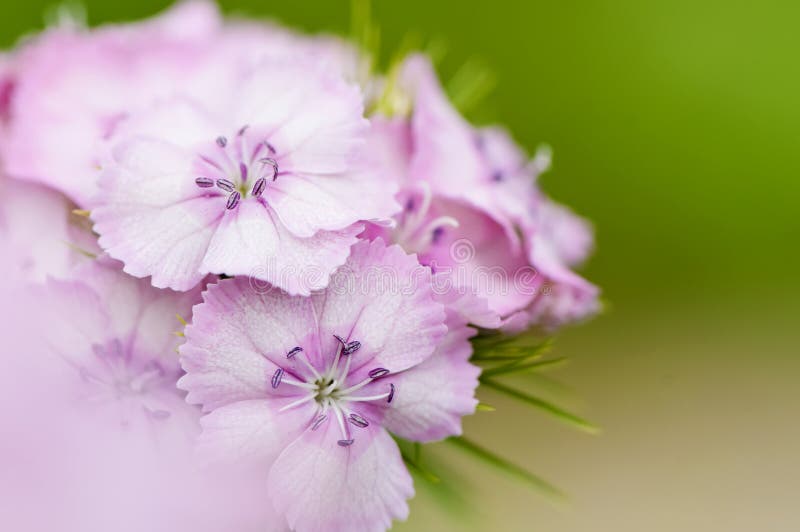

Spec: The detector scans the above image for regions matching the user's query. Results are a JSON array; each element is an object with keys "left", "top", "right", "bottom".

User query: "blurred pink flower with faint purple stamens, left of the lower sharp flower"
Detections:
[{"left": 35, "top": 258, "right": 200, "bottom": 441}]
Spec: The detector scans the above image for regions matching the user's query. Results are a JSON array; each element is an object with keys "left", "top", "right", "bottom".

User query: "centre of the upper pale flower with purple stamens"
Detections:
[{"left": 194, "top": 126, "right": 278, "bottom": 210}]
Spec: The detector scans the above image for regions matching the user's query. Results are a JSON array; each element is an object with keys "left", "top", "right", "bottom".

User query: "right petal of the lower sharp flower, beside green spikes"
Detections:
[{"left": 383, "top": 320, "right": 480, "bottom": 442}]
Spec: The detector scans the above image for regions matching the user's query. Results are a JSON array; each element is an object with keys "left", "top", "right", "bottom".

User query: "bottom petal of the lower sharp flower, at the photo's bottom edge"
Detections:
[{"left": 268, "top": 422, "right": 414, "bottom": 532}]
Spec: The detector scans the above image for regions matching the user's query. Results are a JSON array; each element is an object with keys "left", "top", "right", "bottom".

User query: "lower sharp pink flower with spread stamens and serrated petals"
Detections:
[{"left": 179, "top": 241, "right": 478, "bottom": 532}]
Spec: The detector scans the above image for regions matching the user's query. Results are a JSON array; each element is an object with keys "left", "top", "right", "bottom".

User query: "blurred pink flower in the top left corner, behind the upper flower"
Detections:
[{"left": 0, "top": 2, "right": 222, "bottom": 207}]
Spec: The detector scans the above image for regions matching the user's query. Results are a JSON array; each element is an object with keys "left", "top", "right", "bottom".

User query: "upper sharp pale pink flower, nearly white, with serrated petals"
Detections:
[{"left": 92, "top": 58, "right": 397, "bottom": 294}]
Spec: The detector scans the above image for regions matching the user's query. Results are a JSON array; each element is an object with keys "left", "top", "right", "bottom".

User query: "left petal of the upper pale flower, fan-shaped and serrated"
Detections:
[{"left": 92, "top": 139, "right": 225, "bottom": 290}]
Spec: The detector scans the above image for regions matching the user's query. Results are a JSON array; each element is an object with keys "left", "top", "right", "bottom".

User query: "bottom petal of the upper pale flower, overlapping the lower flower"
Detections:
[{"left": 201, "top": 199, "right": 363, "bottom": 295}]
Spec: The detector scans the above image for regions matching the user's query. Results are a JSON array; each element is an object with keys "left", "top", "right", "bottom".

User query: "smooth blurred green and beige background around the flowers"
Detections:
[{"left": 0, "top": 0, "right": 800, "bottom": 532}]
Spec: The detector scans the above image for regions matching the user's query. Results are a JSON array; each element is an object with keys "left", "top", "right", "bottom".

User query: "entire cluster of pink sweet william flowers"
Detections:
[{"left": 0, "top": 2, "right": 598, "bottom": 532}]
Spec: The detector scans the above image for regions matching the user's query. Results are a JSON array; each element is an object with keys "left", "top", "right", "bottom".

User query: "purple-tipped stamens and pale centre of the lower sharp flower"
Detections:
[{"left": 271, "top": 334, "right": 395, "bottom": 447}]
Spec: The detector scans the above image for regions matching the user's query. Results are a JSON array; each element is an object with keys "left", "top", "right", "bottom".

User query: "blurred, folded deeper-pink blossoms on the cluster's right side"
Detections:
[{"left": 364, "top": 56, "right": 597, "bottom": 330}]
